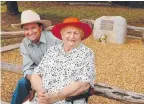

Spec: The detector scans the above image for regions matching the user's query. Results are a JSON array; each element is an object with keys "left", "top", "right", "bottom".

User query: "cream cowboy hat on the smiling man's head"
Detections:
[{"left": 11, "top": 10, "right": 52, "bottom": 29}]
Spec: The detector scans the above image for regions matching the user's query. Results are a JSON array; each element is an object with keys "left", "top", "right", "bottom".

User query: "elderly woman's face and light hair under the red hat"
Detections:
[{"left": 61, "top": 26, "right": 83, "bottom": 48}]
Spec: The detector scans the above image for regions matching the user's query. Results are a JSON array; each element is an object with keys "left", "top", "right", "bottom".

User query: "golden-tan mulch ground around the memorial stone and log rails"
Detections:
[{"left": 1, "top": 37, "right": 144, "bottom": 104}]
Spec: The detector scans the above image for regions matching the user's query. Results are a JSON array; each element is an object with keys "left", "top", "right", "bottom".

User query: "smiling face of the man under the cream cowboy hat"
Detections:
[{"left": 23, "top": 23, "right": 42, "bottom": 43}]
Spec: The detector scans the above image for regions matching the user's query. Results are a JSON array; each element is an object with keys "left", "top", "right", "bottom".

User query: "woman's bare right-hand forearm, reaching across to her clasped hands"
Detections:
[{"left": 38, "top": 82, "right": 90, "bottom": 104}]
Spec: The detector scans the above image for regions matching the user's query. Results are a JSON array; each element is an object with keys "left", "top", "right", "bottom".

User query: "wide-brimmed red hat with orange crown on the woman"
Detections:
[{"left": 52, "top": 17, "right": 92, "bottom": 40}]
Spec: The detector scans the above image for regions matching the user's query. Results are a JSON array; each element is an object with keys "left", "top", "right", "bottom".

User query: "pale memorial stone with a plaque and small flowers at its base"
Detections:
[{"left": 93, "top": 16, "right": 127, "bottom": 44}]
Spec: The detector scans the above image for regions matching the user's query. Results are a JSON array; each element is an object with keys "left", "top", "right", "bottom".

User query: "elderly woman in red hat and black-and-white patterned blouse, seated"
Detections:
[{"left": 30, "top": 18, "right": 95, "bottom": 104}]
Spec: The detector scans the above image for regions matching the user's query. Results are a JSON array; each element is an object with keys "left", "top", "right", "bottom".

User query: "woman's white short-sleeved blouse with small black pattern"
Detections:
[{"left": 34, "top": 43, "right": 95, "bottom": 104}]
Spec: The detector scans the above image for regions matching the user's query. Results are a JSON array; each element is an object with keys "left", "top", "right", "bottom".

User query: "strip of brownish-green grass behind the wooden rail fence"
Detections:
[{"left": 13, "top": 1, "right": 144, "bottom": 21}]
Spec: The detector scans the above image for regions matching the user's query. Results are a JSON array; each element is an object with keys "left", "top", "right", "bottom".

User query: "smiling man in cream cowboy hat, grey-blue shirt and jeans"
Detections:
[{"left": 11, "top": 10, "right": 61, "bottom": 104}]
